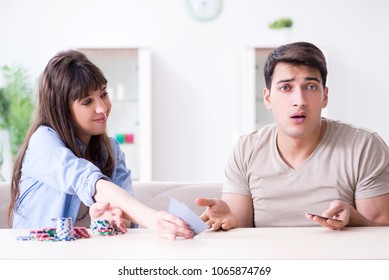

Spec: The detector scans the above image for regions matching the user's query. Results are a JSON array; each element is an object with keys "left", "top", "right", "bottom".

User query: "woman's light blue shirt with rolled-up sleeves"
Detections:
[{"left": 13, "top": 126, "right": 133, "bottom": 228}]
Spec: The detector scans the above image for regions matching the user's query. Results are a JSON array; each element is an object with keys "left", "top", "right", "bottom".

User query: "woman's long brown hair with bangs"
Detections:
[{"left": 8, "top": 50, "right": 114, "bottom": 225}]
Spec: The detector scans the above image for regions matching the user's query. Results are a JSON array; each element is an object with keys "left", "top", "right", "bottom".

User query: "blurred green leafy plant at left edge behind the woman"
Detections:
[{"left": 0, "top": 63, "right": 34, "bottom": 165}]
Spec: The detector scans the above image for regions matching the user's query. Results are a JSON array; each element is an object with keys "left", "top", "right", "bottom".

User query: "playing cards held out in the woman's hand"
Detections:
[{"left": 169, "top": 198, "right": 208, "bottom": 235}]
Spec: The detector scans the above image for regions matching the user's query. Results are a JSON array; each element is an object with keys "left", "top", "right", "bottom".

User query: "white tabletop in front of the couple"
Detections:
[{"left": 0, "top": 227, "right": 389, "bottom": 260}]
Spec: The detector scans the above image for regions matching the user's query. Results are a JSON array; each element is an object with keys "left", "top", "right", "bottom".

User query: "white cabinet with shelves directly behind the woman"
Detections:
[{"left": 78, "top": 48, "right": 152, "bottom": 181}]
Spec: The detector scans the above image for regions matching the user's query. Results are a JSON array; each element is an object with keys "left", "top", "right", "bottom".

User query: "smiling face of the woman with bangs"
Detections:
[{"left": 70, "top": 86, "right": 112, "bottom": 144}]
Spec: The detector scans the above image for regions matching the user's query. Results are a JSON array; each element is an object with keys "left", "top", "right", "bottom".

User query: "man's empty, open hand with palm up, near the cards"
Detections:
[{"left": 196, "top": 198, "right": 238, "bottom": 230}]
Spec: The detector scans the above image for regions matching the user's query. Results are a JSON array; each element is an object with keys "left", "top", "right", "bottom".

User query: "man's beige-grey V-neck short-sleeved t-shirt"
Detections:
[{"left": 223, "top": 119, "right": 389, "bottom": 227}]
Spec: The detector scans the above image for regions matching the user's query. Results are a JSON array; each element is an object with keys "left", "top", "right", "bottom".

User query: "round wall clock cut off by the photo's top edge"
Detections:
[{"left": 186, "top": 0, "right": 222, "bottom": 21}]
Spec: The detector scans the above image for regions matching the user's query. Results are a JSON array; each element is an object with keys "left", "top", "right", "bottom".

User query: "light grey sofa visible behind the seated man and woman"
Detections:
[{"left": 0, "top": 181, "right": 222, "bottom": 228}]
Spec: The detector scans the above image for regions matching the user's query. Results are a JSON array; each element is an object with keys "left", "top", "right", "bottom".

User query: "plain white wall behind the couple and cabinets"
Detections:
[{"left": 0, "top": 0, "right": 389, "bottom": 181}]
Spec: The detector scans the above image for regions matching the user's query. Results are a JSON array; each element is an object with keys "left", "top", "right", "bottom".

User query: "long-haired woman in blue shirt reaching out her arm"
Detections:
[{"left": 8, "top": 50, "right": 194, "bottom": 239}]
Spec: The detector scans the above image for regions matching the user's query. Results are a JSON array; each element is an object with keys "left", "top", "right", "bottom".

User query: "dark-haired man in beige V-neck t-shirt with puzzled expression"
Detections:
[{"left": 196, "top": 42, "right": 389, "bottom": 230}]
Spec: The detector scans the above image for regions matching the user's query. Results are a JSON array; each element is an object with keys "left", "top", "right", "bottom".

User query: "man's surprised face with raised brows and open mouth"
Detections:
[{"left": 264, "top": 62, "right": 328, "bottom": 138}]
